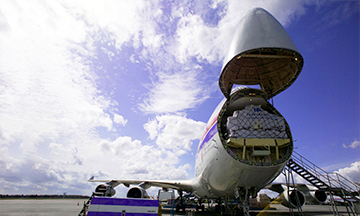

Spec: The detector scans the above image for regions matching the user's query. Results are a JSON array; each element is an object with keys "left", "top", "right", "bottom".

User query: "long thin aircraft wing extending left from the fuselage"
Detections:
[{"left": 88, "top": 178, "right": 193, "bottom": 192}]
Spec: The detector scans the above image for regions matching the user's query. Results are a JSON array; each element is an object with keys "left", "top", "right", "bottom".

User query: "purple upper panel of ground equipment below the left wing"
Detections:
[{"left": 91, "top": 197, "right": 159, "bottom": 207}]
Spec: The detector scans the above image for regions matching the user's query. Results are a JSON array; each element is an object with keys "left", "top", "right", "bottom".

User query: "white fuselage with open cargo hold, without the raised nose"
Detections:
[{"left": 193, "top": 88, "right": 293, "bottom": 198}]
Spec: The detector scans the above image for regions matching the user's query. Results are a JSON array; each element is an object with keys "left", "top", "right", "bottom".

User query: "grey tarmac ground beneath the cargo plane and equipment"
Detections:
[{"left": 0, "top": 199, "right": 356, "bottom": 216}]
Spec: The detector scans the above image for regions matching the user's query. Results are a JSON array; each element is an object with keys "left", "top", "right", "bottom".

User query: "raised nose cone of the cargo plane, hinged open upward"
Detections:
[{"left": 219, "top": 8, "right": 303, "bottom": 97}]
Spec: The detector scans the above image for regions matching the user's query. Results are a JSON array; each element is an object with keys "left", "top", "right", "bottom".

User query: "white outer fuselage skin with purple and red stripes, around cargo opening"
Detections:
[{"left": 192, "top": 93, "right": 286, "bottom": 198}]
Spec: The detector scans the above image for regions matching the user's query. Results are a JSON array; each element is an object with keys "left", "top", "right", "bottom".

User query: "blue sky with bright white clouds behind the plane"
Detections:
[{"left": 0, "top": 0, "right": 360, "bottom": 196}]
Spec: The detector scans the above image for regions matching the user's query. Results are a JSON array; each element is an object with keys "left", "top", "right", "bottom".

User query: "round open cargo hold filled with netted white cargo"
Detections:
[{"left": 218, "top": 88, "right": 293, "bottom": 166}]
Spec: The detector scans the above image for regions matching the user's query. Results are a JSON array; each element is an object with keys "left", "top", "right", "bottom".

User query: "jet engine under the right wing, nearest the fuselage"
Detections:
[{"left": 279, "top": 189, "right": 306, "bottom": 208}]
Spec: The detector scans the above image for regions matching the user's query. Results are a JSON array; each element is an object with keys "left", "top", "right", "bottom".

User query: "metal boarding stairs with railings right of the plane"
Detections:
[{"left": 287, "top": 151, "right": 360, "bottom": 215}]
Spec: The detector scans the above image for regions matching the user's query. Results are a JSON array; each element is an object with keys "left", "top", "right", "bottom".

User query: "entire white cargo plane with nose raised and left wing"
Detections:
[{"left": 89, "top": 8, "right": 305, "bottom": 215}]
